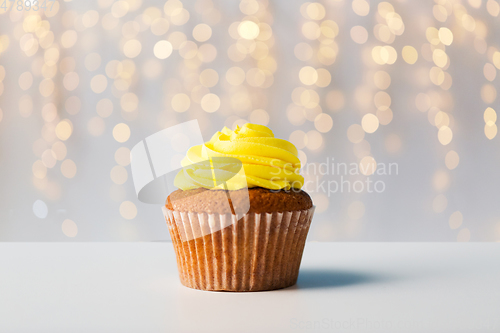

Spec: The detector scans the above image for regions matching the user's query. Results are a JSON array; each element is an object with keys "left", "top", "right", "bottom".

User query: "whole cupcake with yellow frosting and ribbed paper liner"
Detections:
[{"left": 164, "top": 124, "right": 314, "bottom": 292}]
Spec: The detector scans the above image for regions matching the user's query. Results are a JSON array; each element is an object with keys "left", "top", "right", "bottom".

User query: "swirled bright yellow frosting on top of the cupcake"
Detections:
[{"left": 174, "top": 124, "right": 304, "bottom": 190}]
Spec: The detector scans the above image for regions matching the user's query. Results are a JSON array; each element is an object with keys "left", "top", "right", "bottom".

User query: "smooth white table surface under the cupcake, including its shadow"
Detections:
[{"left": 0, "top": 242, "right": 500, "bottom": 333}]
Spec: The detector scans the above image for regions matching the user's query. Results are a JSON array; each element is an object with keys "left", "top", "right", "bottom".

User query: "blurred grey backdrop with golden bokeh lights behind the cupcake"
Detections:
[{"left": 0, "top": 0, "right": 500, "bottom": 241}]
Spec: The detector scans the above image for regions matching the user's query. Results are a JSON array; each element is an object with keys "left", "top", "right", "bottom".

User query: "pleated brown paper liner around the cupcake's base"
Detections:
[{"left": 164, "top": 207, "right": 314, "bottom": 291}]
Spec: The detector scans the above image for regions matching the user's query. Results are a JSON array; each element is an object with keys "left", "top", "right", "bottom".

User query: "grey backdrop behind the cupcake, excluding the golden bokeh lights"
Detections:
[{"left": 0, "top": 1, "right": 500, "bottom": 241}]
